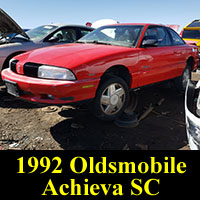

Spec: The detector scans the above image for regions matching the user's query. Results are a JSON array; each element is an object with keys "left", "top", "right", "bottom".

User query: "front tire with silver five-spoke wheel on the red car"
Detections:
[{"left": 92, "top": 76, "right": 129, "bottom": 121}]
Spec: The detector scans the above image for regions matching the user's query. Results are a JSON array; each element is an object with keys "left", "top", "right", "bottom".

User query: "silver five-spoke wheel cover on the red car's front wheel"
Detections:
[{"left": 100, "top": 83, "right": 126, "bottom": 115}]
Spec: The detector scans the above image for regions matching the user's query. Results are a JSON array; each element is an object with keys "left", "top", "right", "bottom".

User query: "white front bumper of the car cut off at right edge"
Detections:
[{"left": 185, "top": 81, "right": 200, "bottom": 150}]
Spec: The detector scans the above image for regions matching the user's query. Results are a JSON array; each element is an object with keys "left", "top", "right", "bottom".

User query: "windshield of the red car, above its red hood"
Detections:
[{"left": 78, "top": 25, "right": 143, "bottom": 47}]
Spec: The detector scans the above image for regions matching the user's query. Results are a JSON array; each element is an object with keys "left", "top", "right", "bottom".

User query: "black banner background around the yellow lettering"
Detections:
[{"left": 0, "top": 151, "right": 200, "bottom": 200}]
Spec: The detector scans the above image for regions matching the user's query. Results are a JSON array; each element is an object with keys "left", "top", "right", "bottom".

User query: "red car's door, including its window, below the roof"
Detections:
[{"left": 138, "top": 26, "right": 176, "bottom": 86}]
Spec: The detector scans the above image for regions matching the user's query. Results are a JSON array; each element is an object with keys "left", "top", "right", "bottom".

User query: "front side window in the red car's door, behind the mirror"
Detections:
[{"left": 144, "top": 26, "right": 172, "bottom": 47}]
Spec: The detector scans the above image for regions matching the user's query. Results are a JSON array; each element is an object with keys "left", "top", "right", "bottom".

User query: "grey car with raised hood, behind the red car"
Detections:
[{"left": 0, "top": 9, "right": 94, "bottom": 71}]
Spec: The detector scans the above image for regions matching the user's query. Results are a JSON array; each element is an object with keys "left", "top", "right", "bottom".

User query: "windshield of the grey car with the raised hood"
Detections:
[{"left": 16, "top": 25, "right": 58, "bottom": 41}]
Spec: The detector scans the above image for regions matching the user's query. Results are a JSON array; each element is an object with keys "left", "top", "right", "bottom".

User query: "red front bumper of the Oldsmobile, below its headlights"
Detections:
[{"left": 1, "top": 69, "right": 99, "bottom": 104}]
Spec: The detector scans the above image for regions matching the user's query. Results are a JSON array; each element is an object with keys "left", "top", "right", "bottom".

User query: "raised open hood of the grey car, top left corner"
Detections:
[{"left": 0, "top": 9, "right": 30, "bottom": 39}]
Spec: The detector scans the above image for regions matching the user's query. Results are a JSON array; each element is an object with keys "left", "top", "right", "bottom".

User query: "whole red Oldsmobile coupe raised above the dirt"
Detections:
[{"left": 2, "top": 23, "right": 199, "bottom": 120}]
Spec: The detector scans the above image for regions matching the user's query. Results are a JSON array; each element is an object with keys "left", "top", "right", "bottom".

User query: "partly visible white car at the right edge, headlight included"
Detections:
[{"left": 185, "top": 73, "right": 200, "bottom": 150}]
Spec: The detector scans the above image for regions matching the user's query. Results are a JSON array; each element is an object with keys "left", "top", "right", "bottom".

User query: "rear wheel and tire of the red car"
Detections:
[{"left": 175, "top": 64, "right": 192, "bottom": 92}]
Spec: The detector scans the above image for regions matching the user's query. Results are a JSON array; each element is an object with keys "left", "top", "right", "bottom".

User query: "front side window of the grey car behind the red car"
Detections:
[{"left": 51, "top": 28, "right": 76, "bottom": 43}]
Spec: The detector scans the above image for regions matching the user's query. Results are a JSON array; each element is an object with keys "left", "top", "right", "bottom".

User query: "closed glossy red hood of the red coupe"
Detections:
[{"left": 15, "top": 43, "right": 136, "bottom": 68}]
